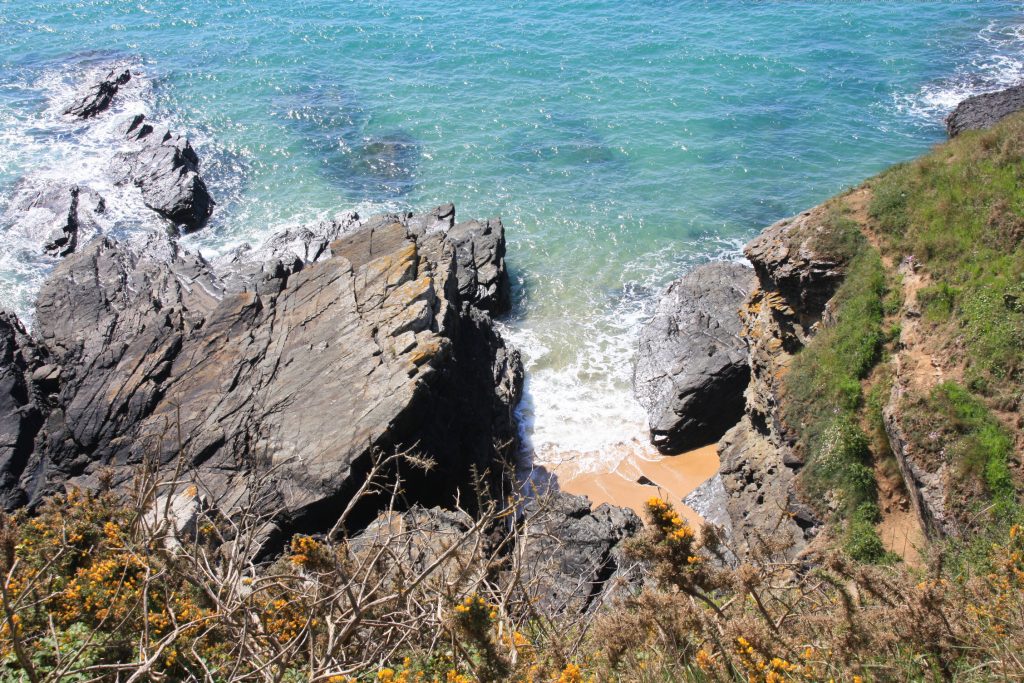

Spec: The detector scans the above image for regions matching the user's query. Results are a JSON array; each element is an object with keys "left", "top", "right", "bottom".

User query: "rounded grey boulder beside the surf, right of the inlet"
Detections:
[{"left": 633, "top": 262, "right": 756, "bottom": 454}]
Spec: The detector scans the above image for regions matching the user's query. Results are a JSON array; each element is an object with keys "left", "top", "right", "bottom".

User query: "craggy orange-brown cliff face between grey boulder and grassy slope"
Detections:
[{"left": 719, "top": 206, "right": 847, "bottom": 556}]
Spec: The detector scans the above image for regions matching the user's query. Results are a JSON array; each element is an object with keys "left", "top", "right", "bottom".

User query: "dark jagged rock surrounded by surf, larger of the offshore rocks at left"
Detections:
[{"left": 114, "top": 114, "right": 214, "bottom": 230}]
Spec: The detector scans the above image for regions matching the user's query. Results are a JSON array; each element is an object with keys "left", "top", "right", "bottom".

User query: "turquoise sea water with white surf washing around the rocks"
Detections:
[{"left": 6, "top": 0, "right": 1024, "bottom": 462}]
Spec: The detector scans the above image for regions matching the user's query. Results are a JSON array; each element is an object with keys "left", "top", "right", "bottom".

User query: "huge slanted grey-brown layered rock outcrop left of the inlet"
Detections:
[{"left": 2, "top": 202, "right": 522, "bottom": 538}]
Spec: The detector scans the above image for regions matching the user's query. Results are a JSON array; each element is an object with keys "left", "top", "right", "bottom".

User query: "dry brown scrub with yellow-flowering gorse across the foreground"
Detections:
[{"left": 0, "top": 483, "right": 1024, "bottom": 683}]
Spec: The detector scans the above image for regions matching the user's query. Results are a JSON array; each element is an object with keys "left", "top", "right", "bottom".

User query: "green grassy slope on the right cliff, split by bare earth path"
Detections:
[{"left": 782, "top": 116, "right": 1024, "bottom": 561}]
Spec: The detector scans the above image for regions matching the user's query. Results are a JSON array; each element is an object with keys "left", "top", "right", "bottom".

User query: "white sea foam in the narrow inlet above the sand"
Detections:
[{"left": 502, "top": 238, "right": 743, "bottom": 471}]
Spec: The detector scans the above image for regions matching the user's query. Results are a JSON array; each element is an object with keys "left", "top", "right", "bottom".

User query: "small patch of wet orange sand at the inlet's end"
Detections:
[{"left": 546, "top": 442, "right": 718, "bottom": 526}]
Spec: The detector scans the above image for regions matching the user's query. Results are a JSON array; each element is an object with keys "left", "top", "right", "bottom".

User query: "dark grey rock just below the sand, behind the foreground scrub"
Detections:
[{"left": 520, "top": 492, "right": 643, "bottom": 612}]
